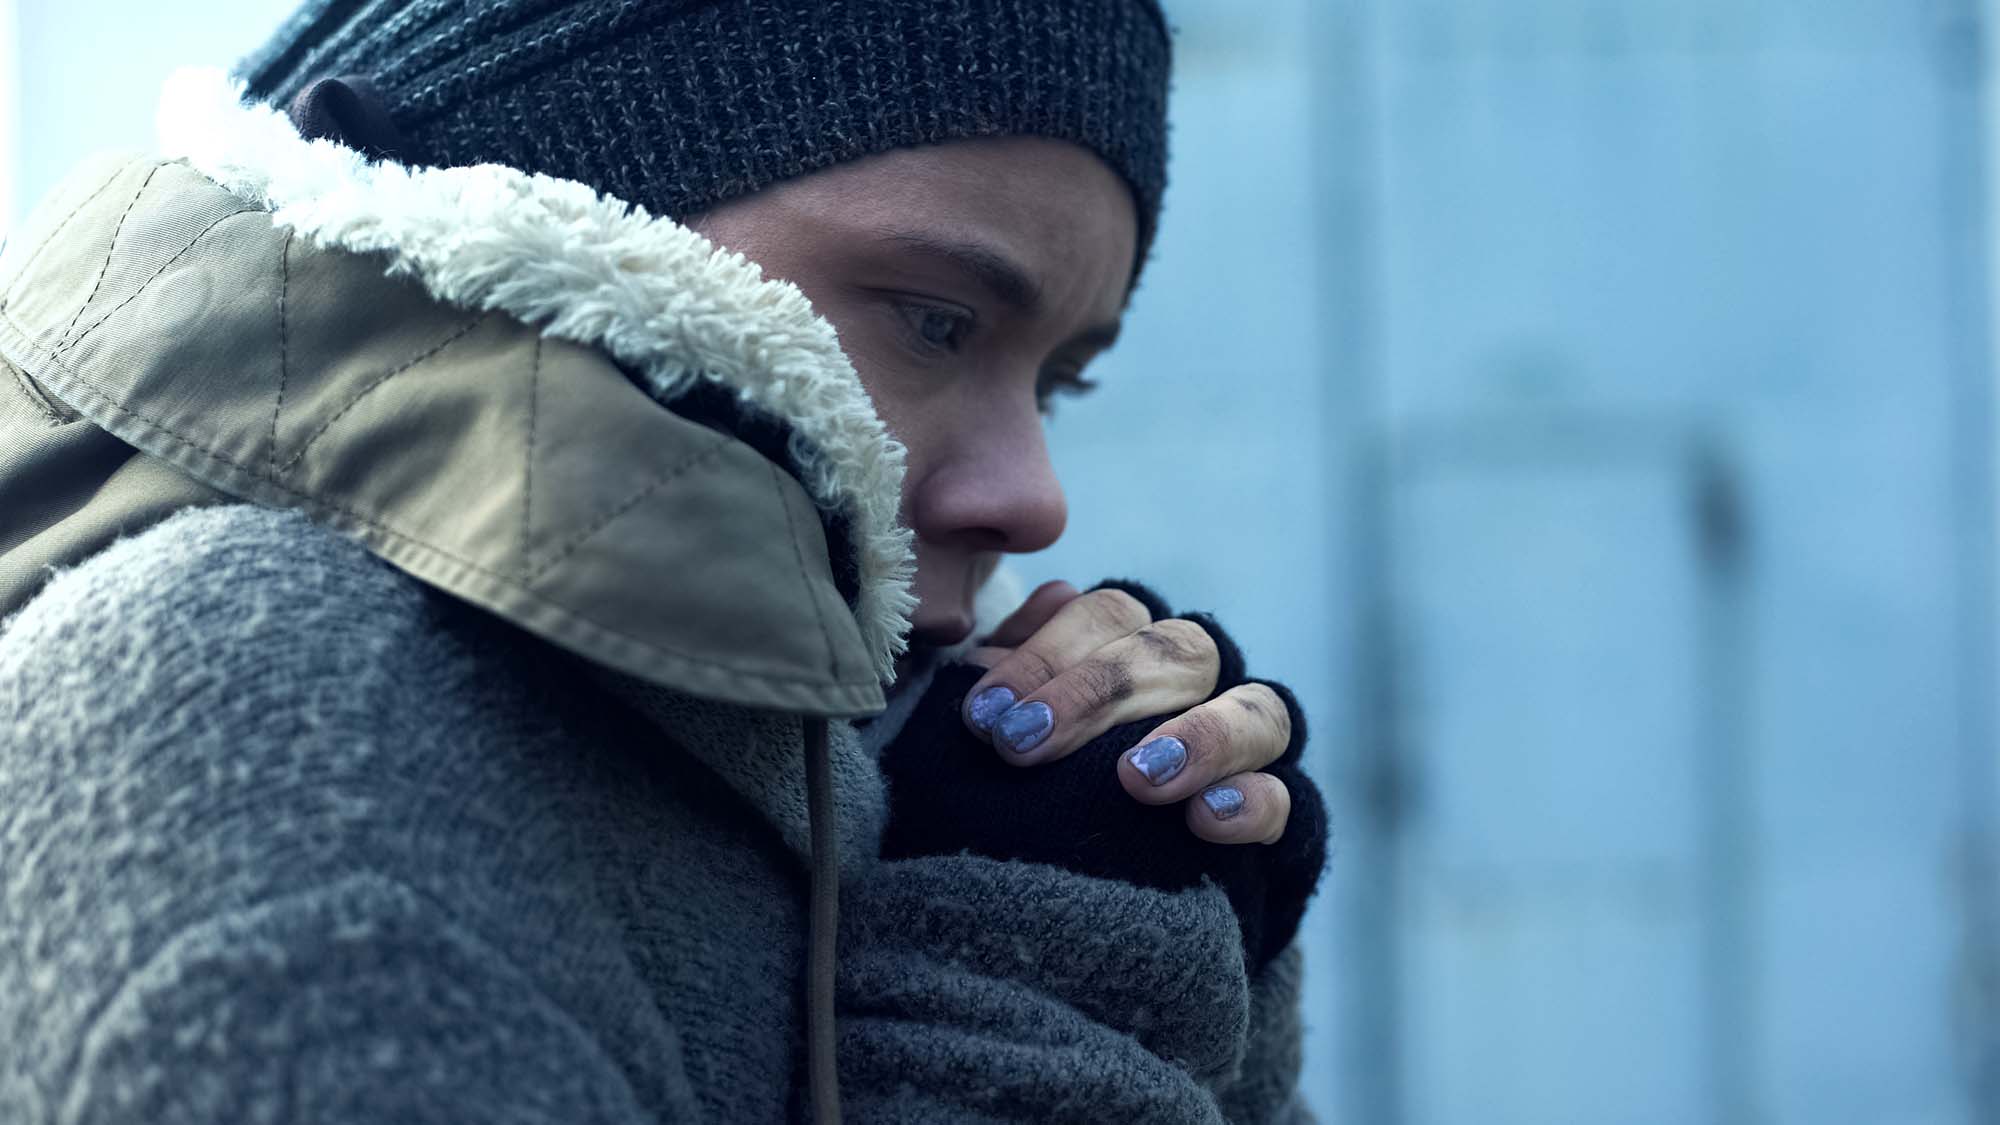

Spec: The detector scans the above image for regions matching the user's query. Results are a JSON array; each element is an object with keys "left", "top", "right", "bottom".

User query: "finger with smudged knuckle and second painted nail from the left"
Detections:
[{"left": 992, "top": 619, "right": 1216, "bottom": 765}]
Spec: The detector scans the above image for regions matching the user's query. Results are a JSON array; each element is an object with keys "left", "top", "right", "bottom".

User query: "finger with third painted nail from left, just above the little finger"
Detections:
[{"left": 1118, "top": 683, "right": 1292, "bottom": 805}]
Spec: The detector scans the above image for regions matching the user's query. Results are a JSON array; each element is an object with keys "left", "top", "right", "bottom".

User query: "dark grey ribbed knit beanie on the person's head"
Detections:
[{"left": 238, "top": 0, "right": 1172, "bottom": 262}]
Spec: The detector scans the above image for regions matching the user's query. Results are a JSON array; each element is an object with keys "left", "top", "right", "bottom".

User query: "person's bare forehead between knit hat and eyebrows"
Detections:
[{"left": 748, "top": 136, "right": 1138, "bottom": 316}]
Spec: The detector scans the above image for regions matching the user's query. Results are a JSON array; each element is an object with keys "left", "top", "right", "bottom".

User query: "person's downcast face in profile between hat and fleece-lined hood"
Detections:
[{"left": 694, "top": 136, "right": 1138, "bottom": 645}]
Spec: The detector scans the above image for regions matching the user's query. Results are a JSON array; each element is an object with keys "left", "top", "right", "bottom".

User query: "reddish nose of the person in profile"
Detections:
[{"left": 906, "top": 400, "right": 1070, "bottom": 552}]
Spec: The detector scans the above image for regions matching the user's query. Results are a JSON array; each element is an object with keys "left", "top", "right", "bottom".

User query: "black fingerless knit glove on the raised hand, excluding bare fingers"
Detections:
[{"left": 882, "top": 583, "right": 1326, "bottom": 971}]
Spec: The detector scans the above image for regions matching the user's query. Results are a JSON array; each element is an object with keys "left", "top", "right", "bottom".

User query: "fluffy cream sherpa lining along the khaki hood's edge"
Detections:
[{"left": 158, "top": 70, "right": 916, "bottom": 683}]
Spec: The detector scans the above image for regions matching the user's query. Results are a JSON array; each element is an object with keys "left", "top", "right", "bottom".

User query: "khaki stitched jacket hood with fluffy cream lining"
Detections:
[{"left": 0, "top": 72, "right": 912, "bottom": 717}]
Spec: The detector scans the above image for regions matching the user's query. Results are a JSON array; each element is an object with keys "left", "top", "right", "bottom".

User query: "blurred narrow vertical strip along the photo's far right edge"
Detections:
[{"left": 1940, "top": 0, "right": 2000, "bottom": 1125}]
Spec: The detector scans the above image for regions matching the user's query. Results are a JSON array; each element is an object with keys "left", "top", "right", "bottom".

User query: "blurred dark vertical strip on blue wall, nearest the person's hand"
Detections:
[{"left": 1310, "top": 0, "right": 1404, "bottom": 1125}]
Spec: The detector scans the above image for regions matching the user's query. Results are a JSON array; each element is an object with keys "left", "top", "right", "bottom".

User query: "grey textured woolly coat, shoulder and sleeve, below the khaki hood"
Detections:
[{"left": 0, "top": 506, "right": 1304, "bottom": 1125}]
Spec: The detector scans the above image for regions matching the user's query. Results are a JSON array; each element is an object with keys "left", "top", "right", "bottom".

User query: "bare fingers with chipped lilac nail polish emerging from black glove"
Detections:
[{"left": 962, "top": 583, "right": 1294, "bottom": 845}]
